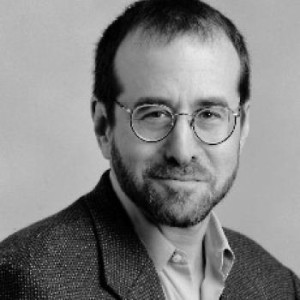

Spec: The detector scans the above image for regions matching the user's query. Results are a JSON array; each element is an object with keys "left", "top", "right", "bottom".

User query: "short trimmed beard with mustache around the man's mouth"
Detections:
[{"left": 111, "top": 140, "right": 239, "bottom": 228}]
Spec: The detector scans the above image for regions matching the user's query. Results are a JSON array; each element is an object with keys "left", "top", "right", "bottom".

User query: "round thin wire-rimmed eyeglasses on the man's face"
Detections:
[{"left": 115, "top": 101, "right": 240, "bottom": 145}]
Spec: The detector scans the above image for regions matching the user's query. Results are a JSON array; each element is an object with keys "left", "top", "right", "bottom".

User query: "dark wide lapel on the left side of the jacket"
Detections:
[{"left": 86, "top": 172, "right": 164, "bottom": 300}]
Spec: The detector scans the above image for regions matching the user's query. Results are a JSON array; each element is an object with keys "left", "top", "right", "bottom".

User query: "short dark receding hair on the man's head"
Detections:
[{"left": 93, "top": 0, "right": 250, "bottom": 125}]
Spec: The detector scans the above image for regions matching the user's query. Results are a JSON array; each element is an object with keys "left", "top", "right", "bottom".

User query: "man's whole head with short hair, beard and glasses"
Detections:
[{"left": 92, "top": 0, "right": 249, "bottom": 227}]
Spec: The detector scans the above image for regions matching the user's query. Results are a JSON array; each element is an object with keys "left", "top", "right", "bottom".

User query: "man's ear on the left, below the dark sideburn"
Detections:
[{"left": 91, "top": 97, "right": 112, "bottom": 160}]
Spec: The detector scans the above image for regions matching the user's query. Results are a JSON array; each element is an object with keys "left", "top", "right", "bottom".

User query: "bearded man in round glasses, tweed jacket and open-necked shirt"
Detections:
[{"left": 0, "top": 0, "right": 300, "bottom": 300}]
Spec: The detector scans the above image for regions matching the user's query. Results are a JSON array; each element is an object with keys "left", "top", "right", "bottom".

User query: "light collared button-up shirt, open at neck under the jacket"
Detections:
[{"left": 110, "top": 172, "right": 234, "bottom": 300}]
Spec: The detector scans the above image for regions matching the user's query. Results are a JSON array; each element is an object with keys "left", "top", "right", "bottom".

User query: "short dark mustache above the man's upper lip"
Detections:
[{"left": 146, "top": 162, "right": 212, "bottom": 181}]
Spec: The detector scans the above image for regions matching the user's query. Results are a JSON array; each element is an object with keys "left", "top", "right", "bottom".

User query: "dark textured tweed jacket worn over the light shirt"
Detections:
[{"left": 0, "top": 173, "right": 300, "bottom": 300}]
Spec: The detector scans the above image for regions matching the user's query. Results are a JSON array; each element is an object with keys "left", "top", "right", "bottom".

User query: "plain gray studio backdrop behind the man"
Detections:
[{"left": 0, "top": 0, "right": 300, "bottom": 274}]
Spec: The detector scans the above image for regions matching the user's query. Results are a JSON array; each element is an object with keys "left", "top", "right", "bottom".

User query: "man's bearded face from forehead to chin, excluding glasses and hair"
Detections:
[{"left": 98, "top": 33, "right": 248, "bottom": 227}]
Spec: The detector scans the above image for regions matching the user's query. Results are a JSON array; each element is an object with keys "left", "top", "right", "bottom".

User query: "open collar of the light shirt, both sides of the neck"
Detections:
[{"left": 110, "top": 171, "right": 234, "bottom": 281}]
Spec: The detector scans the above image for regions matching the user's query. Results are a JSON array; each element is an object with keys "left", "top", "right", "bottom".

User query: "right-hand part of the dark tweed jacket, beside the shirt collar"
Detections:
[{"left": 224, "top": 228, "right": 300, "bottom": 299}]
